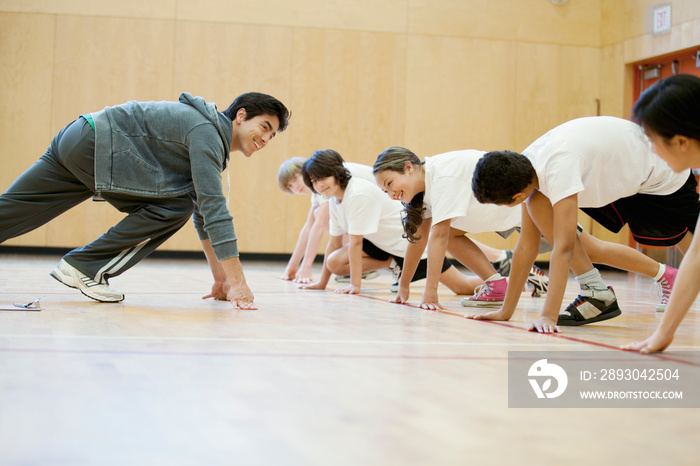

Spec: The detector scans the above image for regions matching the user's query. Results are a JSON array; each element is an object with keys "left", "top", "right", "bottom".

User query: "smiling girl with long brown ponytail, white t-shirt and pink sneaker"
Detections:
[{"left": 374, "top": 147, "right": 547, "bottom": 309}]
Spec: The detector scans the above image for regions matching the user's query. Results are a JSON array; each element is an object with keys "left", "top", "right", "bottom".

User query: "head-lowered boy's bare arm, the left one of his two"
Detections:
[{"left": 468, "top": 203, "right": 541, "bottom": 320}]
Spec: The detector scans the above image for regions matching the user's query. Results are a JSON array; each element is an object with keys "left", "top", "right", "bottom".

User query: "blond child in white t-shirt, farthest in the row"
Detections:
[{"left": 277, "top": 157, "right": 374, "bottom": 283}]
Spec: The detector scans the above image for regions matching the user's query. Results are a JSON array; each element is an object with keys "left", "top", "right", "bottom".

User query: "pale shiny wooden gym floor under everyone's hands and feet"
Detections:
[{"left": 0, "top": 254, "right": 700, "bottom": 466}]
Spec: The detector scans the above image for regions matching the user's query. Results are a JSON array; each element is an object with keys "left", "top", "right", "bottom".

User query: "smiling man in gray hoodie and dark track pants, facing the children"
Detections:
[{"left": 0, "top": 92, "right": 290, "bottom": 309}]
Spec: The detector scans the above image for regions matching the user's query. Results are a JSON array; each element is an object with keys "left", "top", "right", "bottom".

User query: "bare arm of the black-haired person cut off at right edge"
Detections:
[{"left": 622, "top": 221, "right": 700, "bottom": 353}]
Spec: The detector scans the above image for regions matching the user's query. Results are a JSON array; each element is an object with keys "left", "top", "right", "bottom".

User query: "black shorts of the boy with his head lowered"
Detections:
[{"left": 581, "top": 173, "right": 700, "bottom": 246}]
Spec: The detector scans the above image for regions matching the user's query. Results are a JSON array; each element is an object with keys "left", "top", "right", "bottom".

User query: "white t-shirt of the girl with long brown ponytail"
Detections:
[{"left": 423, "top": 150, "right": 521, "bottom": 233}]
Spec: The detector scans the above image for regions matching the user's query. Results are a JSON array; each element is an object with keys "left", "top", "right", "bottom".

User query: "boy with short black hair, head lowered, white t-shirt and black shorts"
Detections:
[{"left": 472, "top": 117, "right": 700, "bottom": 333}]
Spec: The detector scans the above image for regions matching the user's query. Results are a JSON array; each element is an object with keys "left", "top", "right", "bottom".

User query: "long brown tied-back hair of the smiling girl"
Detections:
[{"left": 372, "top": 146, "right": 426, "bottom": 243}]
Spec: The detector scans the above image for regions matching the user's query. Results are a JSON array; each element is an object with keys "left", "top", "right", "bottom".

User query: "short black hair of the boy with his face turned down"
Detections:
[{"left": 472, "top": 151, "right": 535, "bottom": 205}]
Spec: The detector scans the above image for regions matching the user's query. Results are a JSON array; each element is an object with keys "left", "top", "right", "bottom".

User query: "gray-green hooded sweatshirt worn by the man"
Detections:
[{"left": 90, "top": 92, "right": 238, "bottom": 260}]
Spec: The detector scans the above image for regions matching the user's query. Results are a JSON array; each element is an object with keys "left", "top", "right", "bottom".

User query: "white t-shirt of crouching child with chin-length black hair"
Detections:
[{"left": 328, "top": 177, "right": 416, "bottom": 257}]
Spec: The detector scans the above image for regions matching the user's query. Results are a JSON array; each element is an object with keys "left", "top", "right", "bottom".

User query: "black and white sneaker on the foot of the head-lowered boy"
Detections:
[{"left": 557, "top": 286, "right": 622, "bottom": 327}]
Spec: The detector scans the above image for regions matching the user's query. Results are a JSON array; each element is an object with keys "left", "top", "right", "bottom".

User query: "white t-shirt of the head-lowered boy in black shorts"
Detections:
[{"left": 523, "top": 116, "right": 690, "bottom": 207}]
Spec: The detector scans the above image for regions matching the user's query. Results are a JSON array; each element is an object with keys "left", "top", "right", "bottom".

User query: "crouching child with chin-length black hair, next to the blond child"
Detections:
[{"left": 302, "top": 150, "right": 480, "bottom": 294}]
